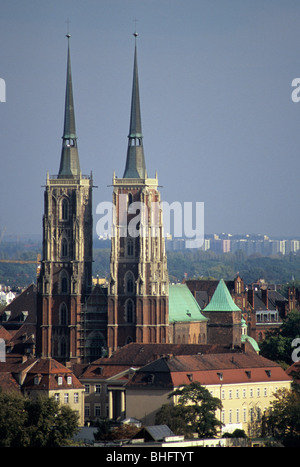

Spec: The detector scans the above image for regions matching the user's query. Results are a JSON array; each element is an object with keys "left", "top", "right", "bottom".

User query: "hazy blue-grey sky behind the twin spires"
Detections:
[{"left": 0, "top": 0, "right": 300, "bottom": 236}]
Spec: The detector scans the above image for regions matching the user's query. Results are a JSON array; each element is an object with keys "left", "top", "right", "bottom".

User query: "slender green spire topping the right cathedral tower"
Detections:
[{"left": 123, "top": 32, "right": 146, "bottom": 178}]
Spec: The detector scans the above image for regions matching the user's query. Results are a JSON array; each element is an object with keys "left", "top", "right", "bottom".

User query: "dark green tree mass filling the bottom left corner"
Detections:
[{"left": 0, "top": 392, "right": 78, "bottom": 447}]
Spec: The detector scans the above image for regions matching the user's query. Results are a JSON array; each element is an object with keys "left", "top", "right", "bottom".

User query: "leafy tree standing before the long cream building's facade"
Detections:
[{"left": 156, "top": 382, "right": 222, "bottom": 438}]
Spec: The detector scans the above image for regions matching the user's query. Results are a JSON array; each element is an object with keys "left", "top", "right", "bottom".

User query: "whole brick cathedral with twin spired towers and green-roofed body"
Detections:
[{"left": 35, "top": 33, "right": 248, "bottom": 365}]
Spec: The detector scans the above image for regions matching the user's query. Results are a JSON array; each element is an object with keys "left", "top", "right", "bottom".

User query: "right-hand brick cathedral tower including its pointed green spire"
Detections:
[{"left": 107, "top": 33, "right": 168, "bottom": 352}]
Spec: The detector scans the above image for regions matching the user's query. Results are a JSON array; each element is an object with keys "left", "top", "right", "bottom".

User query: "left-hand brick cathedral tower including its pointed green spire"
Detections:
[{"left": 37, "top": 34, "right": 93, "bottom": 363}]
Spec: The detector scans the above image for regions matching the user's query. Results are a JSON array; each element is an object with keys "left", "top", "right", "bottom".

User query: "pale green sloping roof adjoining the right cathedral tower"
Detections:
[{"left": 169, "top": 284, "right": 207, "bottom": 323}]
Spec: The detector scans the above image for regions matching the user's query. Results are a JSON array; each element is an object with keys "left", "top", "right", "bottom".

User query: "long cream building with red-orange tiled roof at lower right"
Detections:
[{"left": 126, "top": 352, "right": 292, "bottom": 433}]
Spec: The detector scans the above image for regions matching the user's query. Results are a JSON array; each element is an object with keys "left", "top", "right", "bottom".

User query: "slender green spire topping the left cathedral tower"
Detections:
[{"left": 59, "top": 34, "right": 80, "bottom": 178}]
